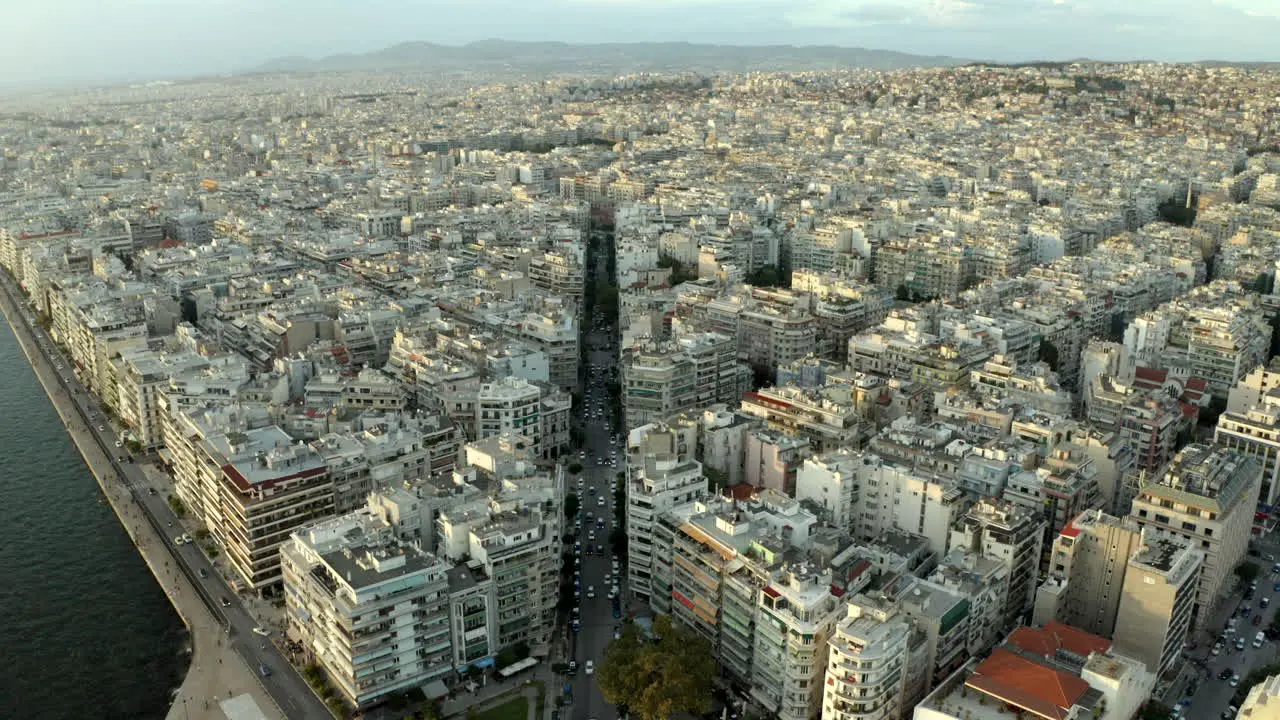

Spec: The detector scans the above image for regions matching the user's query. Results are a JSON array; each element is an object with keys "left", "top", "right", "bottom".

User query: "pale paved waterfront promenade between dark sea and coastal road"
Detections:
[{"left": 0, "top": 277, "right": 288, "bottom": 720}]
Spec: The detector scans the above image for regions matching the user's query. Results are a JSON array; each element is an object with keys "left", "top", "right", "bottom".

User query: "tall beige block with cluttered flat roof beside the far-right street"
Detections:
[{"left": 1129, "top": 443, "right": 1262, "bottom": 626}]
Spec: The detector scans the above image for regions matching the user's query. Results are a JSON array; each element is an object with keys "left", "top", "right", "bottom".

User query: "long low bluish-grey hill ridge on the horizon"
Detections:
[{"left": 251, "top": 40, "right": 969, "bottom": 73}]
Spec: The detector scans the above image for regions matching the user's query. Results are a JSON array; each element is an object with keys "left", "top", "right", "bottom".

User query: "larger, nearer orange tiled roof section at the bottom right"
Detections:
[{"left": 965, "top": 647, "right": 1089, "bottom": 720}]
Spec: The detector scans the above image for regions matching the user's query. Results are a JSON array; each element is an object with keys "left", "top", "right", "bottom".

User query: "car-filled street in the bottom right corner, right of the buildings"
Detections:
[{"left": 1183, "top": 538, "right": 1280, "bottom": 720}]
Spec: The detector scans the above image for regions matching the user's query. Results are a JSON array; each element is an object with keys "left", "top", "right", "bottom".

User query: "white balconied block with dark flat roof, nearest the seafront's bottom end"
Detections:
[{"left": 280, "top": 510, "right": 454, "bottom": 708}]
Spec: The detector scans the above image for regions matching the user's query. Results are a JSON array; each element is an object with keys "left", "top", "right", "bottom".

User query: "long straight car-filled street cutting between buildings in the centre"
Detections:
[{"left": 571, "top": 230, "right": 625, "bottom": 720}]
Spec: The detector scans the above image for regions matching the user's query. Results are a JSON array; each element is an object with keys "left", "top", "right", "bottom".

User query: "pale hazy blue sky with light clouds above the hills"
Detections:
[{"left": 0, "top": 0, "right": 1280, "bottom": 85}]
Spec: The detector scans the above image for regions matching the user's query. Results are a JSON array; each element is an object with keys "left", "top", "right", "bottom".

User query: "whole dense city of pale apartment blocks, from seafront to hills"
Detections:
[{"left": 0, "top": 63, "right": 1280, "bottom": 720}]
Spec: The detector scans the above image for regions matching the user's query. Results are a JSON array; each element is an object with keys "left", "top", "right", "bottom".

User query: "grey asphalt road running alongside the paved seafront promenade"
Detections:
[{"left": 4, "top": 278, "right": 332, "bottom": 720}]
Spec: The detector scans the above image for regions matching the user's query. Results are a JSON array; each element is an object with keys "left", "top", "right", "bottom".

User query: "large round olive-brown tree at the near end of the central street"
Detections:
[{"left": 596, "top": 615, "right": 716, "bottom": 720}]
